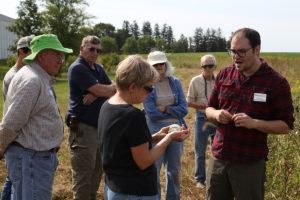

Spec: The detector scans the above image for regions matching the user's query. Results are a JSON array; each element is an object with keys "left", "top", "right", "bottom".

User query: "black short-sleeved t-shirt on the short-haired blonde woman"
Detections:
[{"left": 98, "top": 101, "right": 157, "bottom": 196}]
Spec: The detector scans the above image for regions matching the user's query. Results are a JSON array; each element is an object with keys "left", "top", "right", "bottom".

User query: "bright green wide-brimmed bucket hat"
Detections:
[{"left": 23, "top": 34, "right": 73, "bottom": 64}]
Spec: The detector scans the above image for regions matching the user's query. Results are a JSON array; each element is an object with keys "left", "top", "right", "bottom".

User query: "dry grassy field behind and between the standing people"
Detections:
[{"left": 0, "top": 53, "right": 300, "bottom": 200}]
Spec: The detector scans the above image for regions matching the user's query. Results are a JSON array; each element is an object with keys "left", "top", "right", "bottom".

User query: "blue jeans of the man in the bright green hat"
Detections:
[{"left": 5, "top": 145, "right": 58, "bottom": 200}]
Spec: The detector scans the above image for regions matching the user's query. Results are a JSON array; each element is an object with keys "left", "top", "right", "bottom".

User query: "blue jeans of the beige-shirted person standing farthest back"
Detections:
[{"left": 194, "top": 110, "right": 216, "bottom": 183}]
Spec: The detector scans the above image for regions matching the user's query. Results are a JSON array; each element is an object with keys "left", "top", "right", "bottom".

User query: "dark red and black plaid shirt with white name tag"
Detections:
[{"left": 208, "top": 60, "right": 294, "bottom": 163}]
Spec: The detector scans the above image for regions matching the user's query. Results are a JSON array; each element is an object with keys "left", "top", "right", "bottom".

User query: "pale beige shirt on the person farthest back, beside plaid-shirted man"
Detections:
[{"left": 187, "top": 73, "right": 215, "bottom": 112}]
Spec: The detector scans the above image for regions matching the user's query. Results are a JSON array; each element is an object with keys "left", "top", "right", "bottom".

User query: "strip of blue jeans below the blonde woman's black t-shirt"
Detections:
[{"left": 104, "top": 185, "right": 158, "bottom": 200}]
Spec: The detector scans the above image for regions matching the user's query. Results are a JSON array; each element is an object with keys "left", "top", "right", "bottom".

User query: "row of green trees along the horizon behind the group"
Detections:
[{"left": 8, "top": 0, "right": 228, "bottom": 54}]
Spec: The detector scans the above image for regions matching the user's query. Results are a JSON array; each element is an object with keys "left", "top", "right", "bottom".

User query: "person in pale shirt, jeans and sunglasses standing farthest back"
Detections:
[{"left": 187, "top": 55, "right": 217, "bottom": 188}]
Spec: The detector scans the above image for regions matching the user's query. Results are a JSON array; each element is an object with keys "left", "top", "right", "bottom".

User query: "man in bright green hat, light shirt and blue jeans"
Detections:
[{"left": 0, "top": 34, "right": 73, "bottom": 200}]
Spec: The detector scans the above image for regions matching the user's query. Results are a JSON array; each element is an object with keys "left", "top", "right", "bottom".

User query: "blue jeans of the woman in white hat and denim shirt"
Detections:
[{"left": 147, "top": 120, "right": 184, "bottom": 200}]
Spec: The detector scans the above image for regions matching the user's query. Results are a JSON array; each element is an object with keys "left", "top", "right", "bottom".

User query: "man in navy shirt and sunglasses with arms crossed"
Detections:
[{"left": 66, "top": 36, "right": 116, "bottom": 200}]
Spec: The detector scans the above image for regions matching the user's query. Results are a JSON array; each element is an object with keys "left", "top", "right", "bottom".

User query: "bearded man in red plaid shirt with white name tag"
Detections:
[{"left": 206, "top": 28, "right": 294, "bottom": 200}]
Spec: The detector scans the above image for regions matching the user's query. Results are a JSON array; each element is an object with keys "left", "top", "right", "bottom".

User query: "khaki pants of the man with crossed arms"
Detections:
[{"left": 69, "top": 122, "right": 102, "bottom": 200}]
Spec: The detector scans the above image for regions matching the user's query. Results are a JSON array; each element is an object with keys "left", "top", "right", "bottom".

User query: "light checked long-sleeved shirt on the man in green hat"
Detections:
[{"left": 0, "top": 62, "right": 63, "bottom": 151}]
